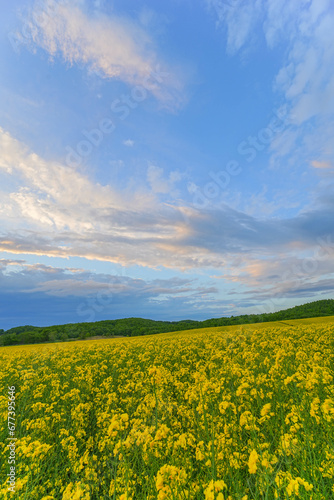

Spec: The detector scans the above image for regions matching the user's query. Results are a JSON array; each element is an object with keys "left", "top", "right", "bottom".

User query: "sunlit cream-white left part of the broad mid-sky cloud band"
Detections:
[{"left": 0, "top": 129, "right": 196, "bottom": 266}]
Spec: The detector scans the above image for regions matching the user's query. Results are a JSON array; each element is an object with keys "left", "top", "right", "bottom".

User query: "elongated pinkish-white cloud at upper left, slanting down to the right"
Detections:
[{"left": 25, "top": 0, "right": 183, "bottom": 105}]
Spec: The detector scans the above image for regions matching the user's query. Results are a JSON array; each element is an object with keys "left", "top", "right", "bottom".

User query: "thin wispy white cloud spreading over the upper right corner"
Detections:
[{"left": 206, "top": 0, "right": 334, "bottom": 168}]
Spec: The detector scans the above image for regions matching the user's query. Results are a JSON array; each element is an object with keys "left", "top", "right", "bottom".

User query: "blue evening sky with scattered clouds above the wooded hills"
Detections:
[{"left": 0, "top": 0, "right": 334, "bottom": 330}]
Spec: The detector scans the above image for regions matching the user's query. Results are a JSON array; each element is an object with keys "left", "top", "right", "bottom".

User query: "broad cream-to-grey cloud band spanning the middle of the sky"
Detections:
[{"left": 0, "top": 130, "right": 334, "bottom": 291}]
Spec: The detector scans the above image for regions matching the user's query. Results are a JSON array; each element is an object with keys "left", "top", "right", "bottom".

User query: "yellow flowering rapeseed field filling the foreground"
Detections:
[{"left": 0, "top": 317, "right": 334, "bottom": 500}]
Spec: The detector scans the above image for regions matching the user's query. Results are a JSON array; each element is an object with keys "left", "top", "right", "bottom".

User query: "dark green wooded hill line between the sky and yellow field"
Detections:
[{"left": 0, "top": 299, "right": 334, "bottom": 346}]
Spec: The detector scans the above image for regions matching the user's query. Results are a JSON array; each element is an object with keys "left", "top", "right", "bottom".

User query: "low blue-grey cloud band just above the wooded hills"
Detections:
[{"left": 0, "top": 254, "right": 334, "bottom": 329}]
